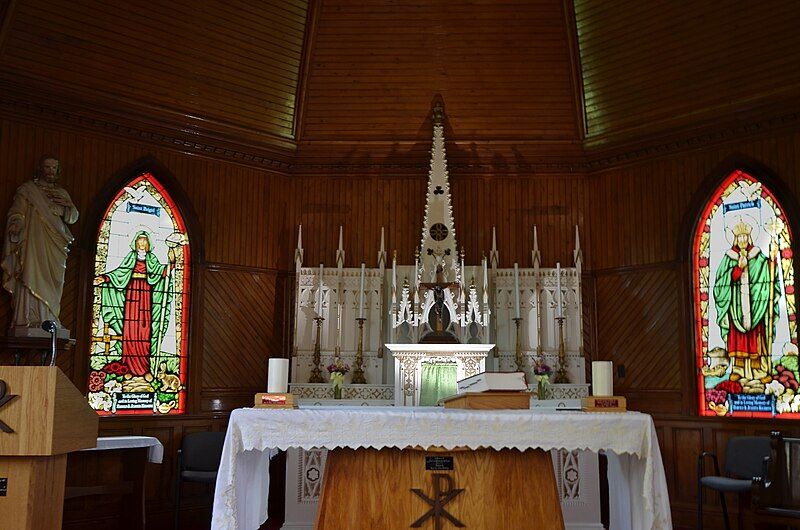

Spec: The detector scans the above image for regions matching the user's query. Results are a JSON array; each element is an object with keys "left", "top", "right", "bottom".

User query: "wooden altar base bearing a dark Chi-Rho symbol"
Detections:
[{"left": 314, "top": 448, "right": 564, "bottom": 530}]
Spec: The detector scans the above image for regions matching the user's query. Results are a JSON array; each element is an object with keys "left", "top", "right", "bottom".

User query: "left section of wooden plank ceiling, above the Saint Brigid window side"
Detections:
[{"left": 0, "top": 0, "right": 307, "bottom": 139}]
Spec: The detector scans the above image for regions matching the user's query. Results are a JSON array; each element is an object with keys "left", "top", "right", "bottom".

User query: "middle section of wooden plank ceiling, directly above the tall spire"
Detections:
[{"left": 302, "top": 0, "right": 578, "bottom": 142}]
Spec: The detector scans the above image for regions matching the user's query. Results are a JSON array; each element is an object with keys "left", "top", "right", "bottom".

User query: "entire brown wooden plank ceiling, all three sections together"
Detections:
[{"left": 0, "top": 0, "right": 800, "bottom": 158}]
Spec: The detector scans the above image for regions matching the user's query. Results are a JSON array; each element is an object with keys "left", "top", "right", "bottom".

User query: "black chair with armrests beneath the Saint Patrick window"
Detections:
[{"left": 697, "top": 436, "right": 770, "bottom": 530}]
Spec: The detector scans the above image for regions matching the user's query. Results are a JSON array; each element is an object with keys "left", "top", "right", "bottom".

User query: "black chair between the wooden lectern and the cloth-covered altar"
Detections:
[{"left": 175, "top": 432, "right": 225, "bottom": 530}]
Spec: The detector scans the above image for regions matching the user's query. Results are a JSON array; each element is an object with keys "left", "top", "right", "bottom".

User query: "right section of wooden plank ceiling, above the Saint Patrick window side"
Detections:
[{"left": 575, "top": 0, "right": 800, "bottom": 139}]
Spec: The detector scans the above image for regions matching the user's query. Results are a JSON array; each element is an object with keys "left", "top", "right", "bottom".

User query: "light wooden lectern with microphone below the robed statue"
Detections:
[{"left": 0, "top": 366, "right": 99, "bottom": 530}]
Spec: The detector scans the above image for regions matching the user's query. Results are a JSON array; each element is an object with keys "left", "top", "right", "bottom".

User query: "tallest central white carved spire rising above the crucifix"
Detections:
[{"left": 420, "top": 103, "right": 458, "bottom": 281}]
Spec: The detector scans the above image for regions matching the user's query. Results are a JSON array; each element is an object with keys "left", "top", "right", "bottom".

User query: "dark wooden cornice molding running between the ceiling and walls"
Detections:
[{"left": 0, "top": 70, "right": 800, "bottom": 172}]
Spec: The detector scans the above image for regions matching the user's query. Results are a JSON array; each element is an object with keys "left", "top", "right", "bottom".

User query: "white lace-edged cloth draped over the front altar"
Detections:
[{"left": 211, "top": 407, "right": 672, "bottom": 530}]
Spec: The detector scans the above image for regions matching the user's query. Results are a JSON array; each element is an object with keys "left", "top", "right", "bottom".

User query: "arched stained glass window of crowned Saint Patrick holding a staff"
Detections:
[{"left": 693, "top": 170, "right": 800, "bottom": 418}]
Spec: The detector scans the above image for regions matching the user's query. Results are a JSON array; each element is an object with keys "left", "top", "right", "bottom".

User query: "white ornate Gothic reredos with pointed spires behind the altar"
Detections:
[{"left": 292, "top": 105, "right": 585, "bottom": 404}]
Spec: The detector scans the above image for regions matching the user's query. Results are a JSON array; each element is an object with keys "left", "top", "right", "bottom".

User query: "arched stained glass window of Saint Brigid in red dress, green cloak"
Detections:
[{"left": 88, "top": 173, "right": 190, "bottom": 415}]
